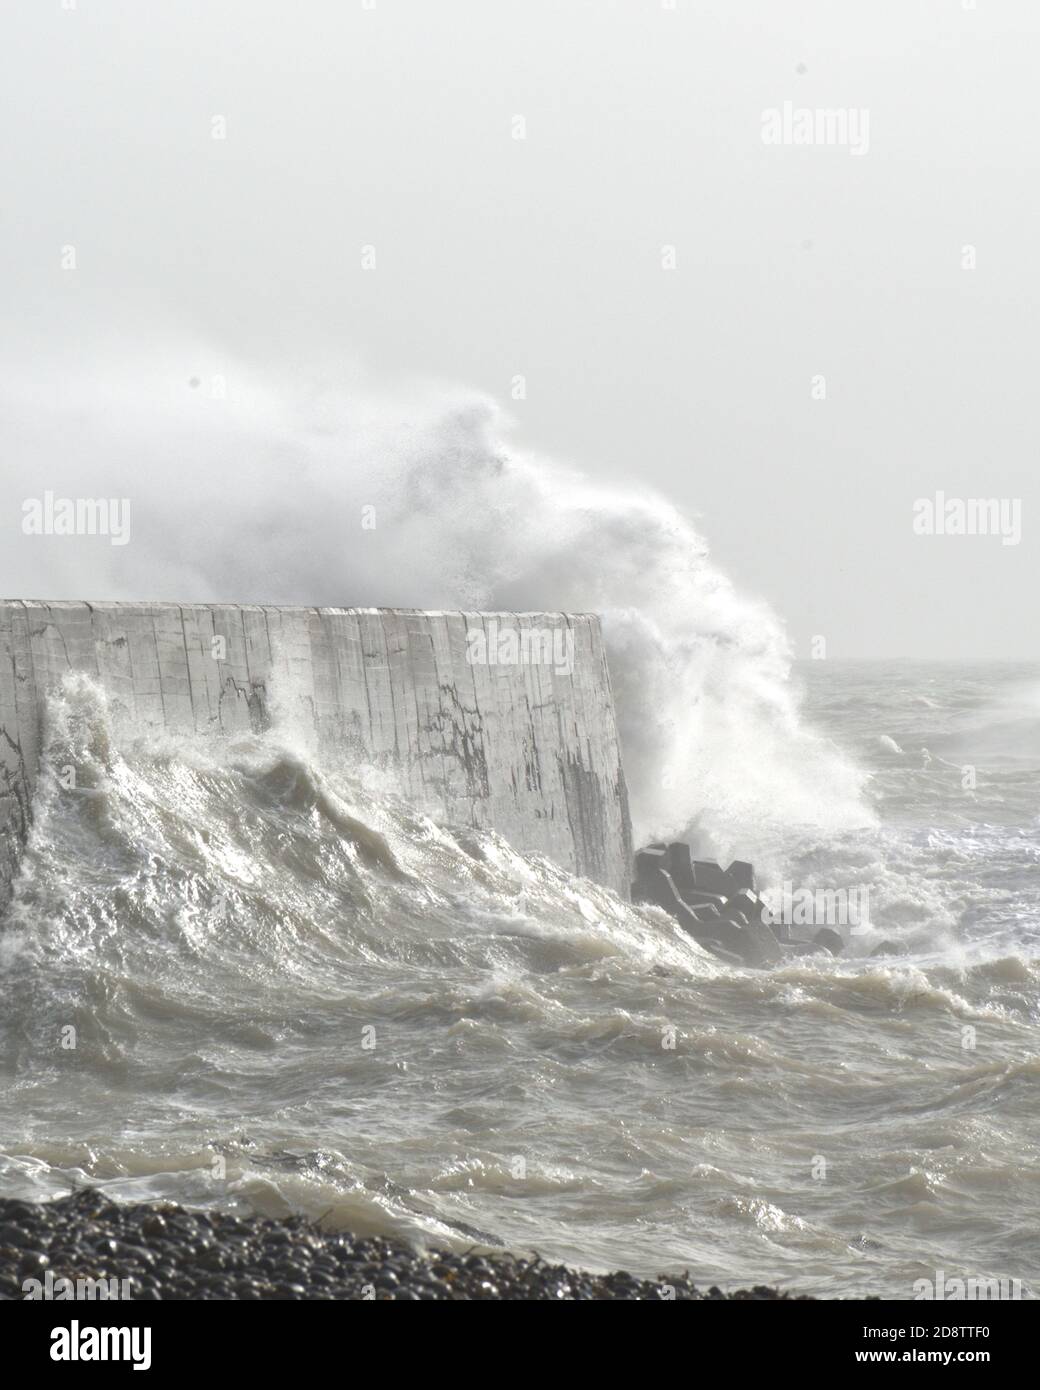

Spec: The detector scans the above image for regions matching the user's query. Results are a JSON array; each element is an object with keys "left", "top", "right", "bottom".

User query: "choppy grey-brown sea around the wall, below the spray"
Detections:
[{"left": 0, "top": 663, "right": 1040, "bottom": 1297}]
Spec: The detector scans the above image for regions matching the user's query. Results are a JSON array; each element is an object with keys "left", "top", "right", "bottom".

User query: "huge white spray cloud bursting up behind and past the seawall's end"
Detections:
[{"left": 0, "top": 349, "right": 866, "bottom": 858}]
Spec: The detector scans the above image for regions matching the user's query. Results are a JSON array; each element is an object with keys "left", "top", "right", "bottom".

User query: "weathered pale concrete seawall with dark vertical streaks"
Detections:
[{"left": 0, "top": 602, "right": 631, "bottom": 902}]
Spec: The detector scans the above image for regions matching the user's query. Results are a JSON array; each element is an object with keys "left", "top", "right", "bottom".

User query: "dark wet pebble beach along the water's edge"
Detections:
[{"left": 0, "top": 1188, "right": 815, "bottom": 1302}]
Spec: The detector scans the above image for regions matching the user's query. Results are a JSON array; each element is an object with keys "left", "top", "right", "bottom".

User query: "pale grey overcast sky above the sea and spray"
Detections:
[{"left": 0, "top": 0, "right": 1040, "bottom": 657}]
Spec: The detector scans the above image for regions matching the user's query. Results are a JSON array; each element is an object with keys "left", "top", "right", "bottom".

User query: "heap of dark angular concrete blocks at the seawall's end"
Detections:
[{"left": 631, "top": 840, "right": 844, "bottom": 969}]
